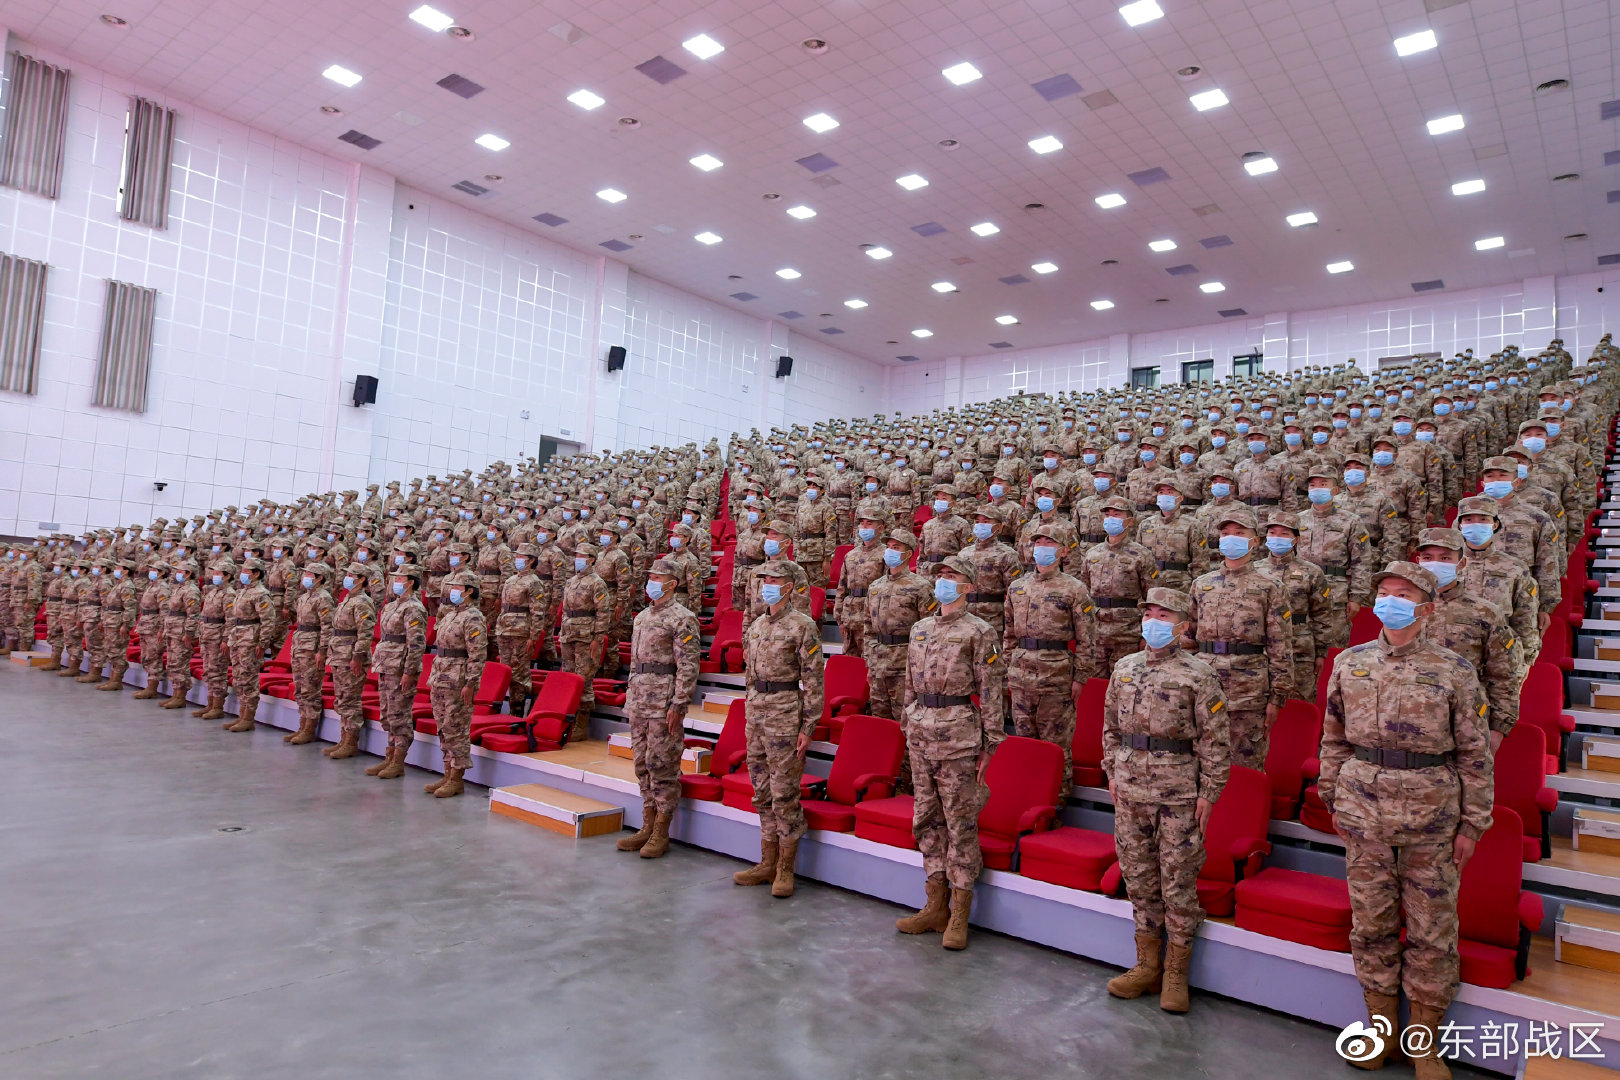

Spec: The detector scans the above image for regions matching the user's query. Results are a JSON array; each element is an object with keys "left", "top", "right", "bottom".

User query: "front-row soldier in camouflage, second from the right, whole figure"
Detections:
[{"left": 1103, "top": 588, "right": 1231, "bottom": 1012}]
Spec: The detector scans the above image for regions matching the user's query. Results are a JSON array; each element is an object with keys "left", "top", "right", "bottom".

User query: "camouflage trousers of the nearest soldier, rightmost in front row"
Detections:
[{"left": 1345, "top": 836, "right": 1460, "bottom": 1009}]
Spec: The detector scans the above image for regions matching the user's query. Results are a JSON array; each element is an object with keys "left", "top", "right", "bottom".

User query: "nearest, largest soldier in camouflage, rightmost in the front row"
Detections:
[{"left": 1317, "top": 562, "right": 1494, "bottom": 1080}]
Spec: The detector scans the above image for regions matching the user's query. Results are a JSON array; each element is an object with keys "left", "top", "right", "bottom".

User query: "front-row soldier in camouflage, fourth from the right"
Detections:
[{"left": 732, "top": 560, "right": 826, "bottom": 897}]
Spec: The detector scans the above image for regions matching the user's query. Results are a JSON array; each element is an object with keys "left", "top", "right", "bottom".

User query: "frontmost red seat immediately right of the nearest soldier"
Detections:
[{"left": 1456, "top": 805, "right": 1545, "bottom": 989}]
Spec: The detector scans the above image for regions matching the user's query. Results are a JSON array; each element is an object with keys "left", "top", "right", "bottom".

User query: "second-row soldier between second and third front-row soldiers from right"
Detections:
[{"left": 1001, "top": 521, "right": 1098, "bottom": 784}]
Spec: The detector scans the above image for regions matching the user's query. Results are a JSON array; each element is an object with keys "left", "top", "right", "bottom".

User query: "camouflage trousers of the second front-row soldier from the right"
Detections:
[{"left": 1115, "top": 800, "right": 1204, "bottom": 946}]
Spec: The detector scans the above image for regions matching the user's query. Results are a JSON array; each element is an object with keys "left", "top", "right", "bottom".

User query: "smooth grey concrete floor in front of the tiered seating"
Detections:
[{"left": 0, "top": 662, "right": 1483, "bottom": 1080}]
